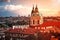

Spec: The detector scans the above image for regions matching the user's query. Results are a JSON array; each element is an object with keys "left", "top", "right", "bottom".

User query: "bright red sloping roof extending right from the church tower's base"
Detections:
[{"left": 30, "top": 21, "right": 60, "bottom": 27}]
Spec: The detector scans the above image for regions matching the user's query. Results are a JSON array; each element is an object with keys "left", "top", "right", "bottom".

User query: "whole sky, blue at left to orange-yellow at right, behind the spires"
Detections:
[{"left": 0, "top": 0, "right": 60, "bottom": 16}]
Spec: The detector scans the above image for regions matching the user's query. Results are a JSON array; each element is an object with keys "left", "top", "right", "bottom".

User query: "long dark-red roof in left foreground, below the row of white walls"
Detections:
[{"left": 7, "top": 28, "right": 35, "bottom": 34}]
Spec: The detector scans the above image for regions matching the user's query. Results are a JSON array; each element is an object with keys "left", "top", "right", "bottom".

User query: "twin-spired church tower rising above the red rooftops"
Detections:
[{"left": 30, "top": 5, "right": 42, "bottom": 26}]
